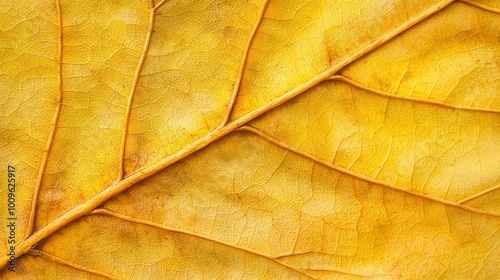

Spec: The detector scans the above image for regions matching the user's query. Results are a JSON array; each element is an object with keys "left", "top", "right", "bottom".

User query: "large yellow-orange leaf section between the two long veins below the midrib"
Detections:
[{"left": 99, "top": 132, "right": 500, "bottom": 279}]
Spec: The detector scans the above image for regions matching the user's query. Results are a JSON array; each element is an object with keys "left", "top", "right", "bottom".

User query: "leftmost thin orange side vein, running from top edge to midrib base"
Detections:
[{"left": 22, "top": 0, "right": 63, "bottom": 239}]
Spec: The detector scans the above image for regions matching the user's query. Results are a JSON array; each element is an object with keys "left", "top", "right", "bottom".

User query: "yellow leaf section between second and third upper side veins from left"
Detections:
[{"left": 126, "top": 0, "right": 264, "bottom": 173}]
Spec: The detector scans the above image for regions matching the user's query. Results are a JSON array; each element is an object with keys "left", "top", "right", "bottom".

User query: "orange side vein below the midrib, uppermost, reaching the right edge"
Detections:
[{"left": 328, "top": 75, "right": 500, "bottom": 113}]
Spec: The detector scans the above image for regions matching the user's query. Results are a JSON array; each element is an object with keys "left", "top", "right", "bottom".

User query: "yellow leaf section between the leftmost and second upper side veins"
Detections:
[{"left": 36, "top": 1, "right": 149, "bottom": 227}]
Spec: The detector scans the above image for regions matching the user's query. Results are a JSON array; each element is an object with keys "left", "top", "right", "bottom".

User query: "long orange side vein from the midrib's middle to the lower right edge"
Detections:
[{"left": 238, "top": 126, "right": 500, "bottom": 217}]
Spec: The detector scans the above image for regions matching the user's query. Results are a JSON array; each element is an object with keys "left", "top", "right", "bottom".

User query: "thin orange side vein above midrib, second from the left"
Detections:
[{"left": 117, "top": 3, "right": 156, "bottom": 181}]
